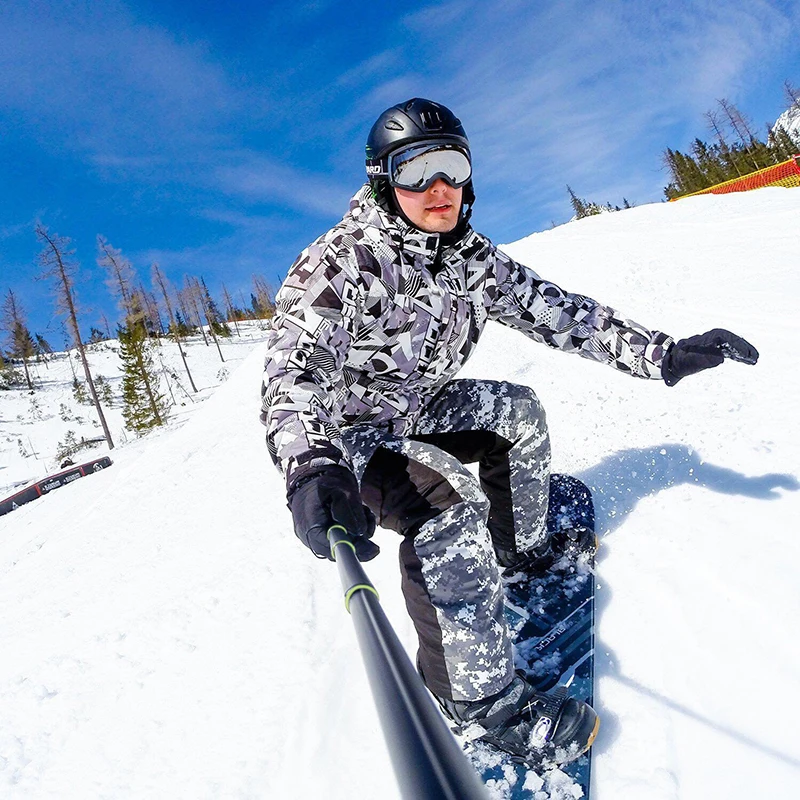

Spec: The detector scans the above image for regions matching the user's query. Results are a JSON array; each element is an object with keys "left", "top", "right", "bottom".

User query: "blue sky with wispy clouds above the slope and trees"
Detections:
[{"left": 0, "top": 0, "right": 800, "bottom": 346}]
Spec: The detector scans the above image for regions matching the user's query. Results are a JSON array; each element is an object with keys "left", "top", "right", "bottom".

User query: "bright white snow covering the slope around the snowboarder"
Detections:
[{"left": 0, "top": 188, "right": 800, "bottom": 800}]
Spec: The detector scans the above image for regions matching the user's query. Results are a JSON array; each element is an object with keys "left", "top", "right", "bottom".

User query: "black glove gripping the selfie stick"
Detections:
[{"left": 287, "top": 465, "right": 380, "bottom": 561}]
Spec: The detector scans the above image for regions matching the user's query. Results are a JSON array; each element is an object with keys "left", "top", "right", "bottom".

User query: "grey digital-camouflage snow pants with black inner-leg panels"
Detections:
[{"left": 344, "top": 380, "right": 550, "bottom": 700}]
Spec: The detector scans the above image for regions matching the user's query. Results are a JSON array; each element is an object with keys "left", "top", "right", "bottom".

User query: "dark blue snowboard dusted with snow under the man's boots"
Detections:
[{"left": 467, "top": 474, "right": 595, "bottom": 800}]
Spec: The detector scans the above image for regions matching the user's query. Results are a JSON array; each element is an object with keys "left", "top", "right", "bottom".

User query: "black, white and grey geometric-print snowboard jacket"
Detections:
[{"left": 261, "top": 184, "right": 673, "bottom": 488}]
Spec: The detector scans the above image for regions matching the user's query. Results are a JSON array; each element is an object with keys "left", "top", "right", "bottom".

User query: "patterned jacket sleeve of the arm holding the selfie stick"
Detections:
[{"left": 261, "top": 238, "right": 363, "bottom": 489}]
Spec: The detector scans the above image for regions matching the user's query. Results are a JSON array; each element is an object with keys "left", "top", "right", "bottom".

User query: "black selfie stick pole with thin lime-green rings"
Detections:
[{"left": 328, "top": 525, "right": 488, "bottom": 800}]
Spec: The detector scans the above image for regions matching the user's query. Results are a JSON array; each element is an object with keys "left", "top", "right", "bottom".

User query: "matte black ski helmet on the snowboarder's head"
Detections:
[{"left": 366, "top": 97, "right": 475, "bottom": 219}]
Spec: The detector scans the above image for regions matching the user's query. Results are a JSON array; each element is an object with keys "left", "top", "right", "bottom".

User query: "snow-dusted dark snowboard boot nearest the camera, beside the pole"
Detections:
[{"left": 437, "top": 670, "right": 600, "bottom": 768}]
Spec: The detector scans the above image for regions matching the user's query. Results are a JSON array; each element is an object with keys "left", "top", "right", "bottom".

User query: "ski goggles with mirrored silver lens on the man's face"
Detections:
[{"left": 367, "top": 142, "right": 472, "bottom": 192}]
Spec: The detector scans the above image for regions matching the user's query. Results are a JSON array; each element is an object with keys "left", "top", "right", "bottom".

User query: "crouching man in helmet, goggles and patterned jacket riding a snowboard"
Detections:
[{"left": 261, "top": 98, "right": 758, "bottom": 761}]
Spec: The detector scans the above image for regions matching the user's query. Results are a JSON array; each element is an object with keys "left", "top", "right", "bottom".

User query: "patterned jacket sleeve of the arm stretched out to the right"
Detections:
[{"left": 488, "top": 248, "right": 673, "bottom": 380}]
